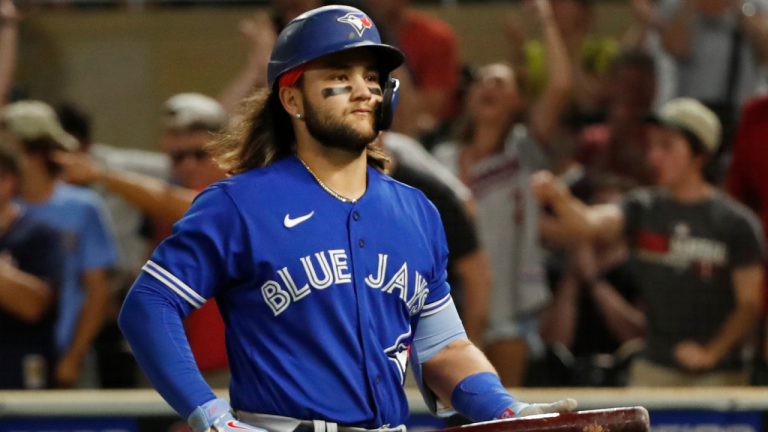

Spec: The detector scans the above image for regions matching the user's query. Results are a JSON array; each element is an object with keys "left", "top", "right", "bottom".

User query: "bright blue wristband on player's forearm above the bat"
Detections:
[{"left": 451, "top": 372, "right": 527, "bottom": 422}]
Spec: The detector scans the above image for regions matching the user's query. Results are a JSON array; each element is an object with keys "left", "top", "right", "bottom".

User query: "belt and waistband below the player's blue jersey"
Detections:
[{"left": 237, "top": 411, "right": 406, "bottom": 432}]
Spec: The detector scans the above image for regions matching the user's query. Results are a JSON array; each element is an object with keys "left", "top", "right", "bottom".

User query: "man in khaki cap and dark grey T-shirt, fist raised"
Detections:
[{"left": 533, "top": 98, "right": 764, "bottom": 386}]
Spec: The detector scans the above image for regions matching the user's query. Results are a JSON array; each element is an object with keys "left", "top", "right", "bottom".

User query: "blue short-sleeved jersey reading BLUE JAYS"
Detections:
[{"left": 136, "top": 156, "right": 451, "bottom": 428}]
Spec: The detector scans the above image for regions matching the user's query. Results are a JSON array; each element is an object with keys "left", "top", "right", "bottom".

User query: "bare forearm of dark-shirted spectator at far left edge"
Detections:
[{"left": 0, "top": 267, "right": 53, "bottom": 323}]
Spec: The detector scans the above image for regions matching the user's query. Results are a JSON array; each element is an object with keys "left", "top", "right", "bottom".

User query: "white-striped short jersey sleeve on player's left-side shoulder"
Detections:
[{"left": 140, "top": 186, "right": 248, "bottom": 313}]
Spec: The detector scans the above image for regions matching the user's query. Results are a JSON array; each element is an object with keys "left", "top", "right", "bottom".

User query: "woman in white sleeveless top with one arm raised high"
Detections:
[{"left": 434, "top": 0, "right": 571, "bottom": 386}]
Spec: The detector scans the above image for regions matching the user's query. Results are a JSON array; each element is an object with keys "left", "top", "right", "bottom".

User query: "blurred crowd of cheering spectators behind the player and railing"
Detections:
[{"left": 0, "top": 0, "right": 768, "bottom": 389}]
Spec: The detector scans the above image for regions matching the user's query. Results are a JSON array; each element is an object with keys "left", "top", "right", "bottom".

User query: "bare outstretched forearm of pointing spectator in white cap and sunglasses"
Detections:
[{"left": 102, "top": 171, "right": 197, "bottom": 223}]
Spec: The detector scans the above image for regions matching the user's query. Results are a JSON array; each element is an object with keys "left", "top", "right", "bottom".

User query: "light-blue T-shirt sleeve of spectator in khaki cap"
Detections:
[{"left": 78, "top": 196, "right": 117, "bottom": 271}]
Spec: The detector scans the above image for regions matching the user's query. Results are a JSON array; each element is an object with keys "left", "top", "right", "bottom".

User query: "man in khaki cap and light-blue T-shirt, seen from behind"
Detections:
[{"left": 0, "top": 101, "right": 116, "bottom": 387}]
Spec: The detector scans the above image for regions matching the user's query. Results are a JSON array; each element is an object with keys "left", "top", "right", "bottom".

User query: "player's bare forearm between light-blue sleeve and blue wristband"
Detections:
[{"left": 423, "top": 339, "right": 496, "bottom": 405}]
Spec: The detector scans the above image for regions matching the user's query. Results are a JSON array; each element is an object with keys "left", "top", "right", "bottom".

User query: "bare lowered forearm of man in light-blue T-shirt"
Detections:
[{"left": 65, "top": 269, "right": 109, "bottom": 363}]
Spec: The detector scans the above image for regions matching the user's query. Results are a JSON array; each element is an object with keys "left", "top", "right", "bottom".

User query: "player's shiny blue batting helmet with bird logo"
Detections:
[{"left": 267, "top": 5, "right": 405, "bottom": 88}]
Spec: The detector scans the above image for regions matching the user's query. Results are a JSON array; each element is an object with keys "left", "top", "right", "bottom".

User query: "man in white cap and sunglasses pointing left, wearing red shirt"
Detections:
[{"left": 57, "top": 93, "right": 229, "bottom": 387}]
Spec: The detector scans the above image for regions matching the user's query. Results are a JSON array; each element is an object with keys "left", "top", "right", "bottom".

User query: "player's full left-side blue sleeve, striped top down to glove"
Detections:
[{"left": 118, "top": 186, "right": 247, "bottom": 417}]
